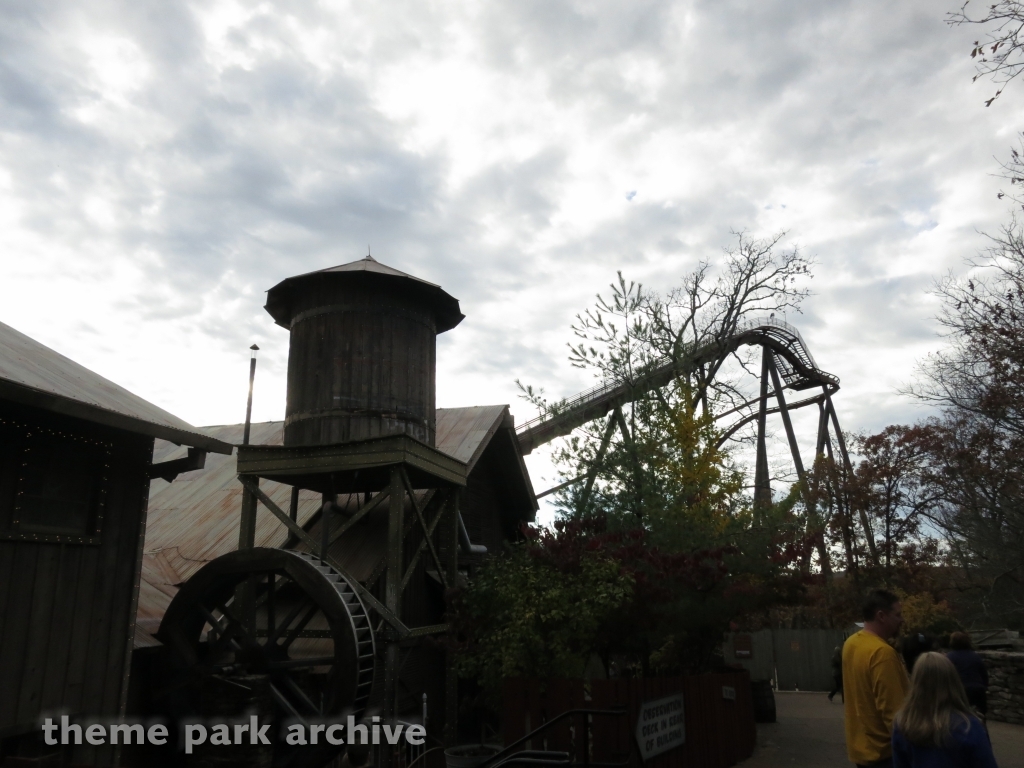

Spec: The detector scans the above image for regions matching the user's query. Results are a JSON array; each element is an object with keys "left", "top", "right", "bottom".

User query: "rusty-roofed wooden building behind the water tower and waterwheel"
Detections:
[{"left": 129, "top": 406, "right": 538, "bottom": 737}]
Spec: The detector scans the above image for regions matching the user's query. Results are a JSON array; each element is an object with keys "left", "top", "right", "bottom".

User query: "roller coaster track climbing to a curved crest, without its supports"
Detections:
[{"left": 516, "top": 317, "right": 839, "bottom": 456}]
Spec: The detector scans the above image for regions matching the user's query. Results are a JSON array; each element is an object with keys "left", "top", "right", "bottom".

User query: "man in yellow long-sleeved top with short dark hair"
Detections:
[{"left": 843, "top": 590, "right": 910, "bottom": 768}]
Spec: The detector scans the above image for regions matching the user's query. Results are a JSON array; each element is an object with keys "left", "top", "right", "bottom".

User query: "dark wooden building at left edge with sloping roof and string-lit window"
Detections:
[{"left": 0, "top": 324, "right": 231, "bottom": 765}]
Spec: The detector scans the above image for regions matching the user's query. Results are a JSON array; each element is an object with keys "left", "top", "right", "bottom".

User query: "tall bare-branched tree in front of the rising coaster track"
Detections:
[{"left": 520, "top": 232, "right": 812, "bottom": 523}]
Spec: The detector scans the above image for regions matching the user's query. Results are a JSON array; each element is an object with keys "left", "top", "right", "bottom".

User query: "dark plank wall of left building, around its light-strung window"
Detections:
[{"left": 0, "top": 402, "right": 154, "bottom": 764}]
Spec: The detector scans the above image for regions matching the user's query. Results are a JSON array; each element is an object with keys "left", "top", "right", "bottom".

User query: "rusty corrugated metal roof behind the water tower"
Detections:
[{"left": 136, "top": 406, "right": 532, "bottom": 647}]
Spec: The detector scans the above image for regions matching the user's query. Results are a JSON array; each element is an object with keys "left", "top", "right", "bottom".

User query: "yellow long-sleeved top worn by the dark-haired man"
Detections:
[{"left": 843, "top": 630, "right": 910, "bottom": 765}]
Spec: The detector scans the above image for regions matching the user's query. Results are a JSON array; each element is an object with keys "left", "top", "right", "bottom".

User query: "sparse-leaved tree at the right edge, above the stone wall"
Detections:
[{"left": 911, "top": 220, "right": 1024, "bottom": 622}]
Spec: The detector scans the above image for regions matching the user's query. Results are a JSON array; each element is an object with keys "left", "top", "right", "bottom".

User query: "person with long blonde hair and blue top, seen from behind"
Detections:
[{"left": 893, "top": 651, "right": 998, "bottom": 768}]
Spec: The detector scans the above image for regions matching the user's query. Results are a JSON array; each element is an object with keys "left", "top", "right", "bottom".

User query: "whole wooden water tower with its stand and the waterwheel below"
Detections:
[{"left": 160, "top": 256, "right": 472, "bottom": 766}]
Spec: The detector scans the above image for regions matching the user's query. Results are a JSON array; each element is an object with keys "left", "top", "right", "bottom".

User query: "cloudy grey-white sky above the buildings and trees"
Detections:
[{"left": 0, "top": 0, "right": 1024, "bottom": 518}]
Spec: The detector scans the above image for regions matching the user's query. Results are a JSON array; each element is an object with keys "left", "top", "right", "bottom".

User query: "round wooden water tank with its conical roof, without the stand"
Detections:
[{"left": 266, "top": 256, "right": 463, "bottom": 445}]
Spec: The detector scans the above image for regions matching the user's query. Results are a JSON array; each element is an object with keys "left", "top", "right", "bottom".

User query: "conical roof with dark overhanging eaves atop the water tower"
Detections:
[{"left": 264, "top": 255, "right": 466, "bottom": 334}]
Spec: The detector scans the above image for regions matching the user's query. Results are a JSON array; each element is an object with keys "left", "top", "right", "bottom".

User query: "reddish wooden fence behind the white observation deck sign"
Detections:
[{"left": 502, "top": 670, "right": 757, "bottom": 768}]
